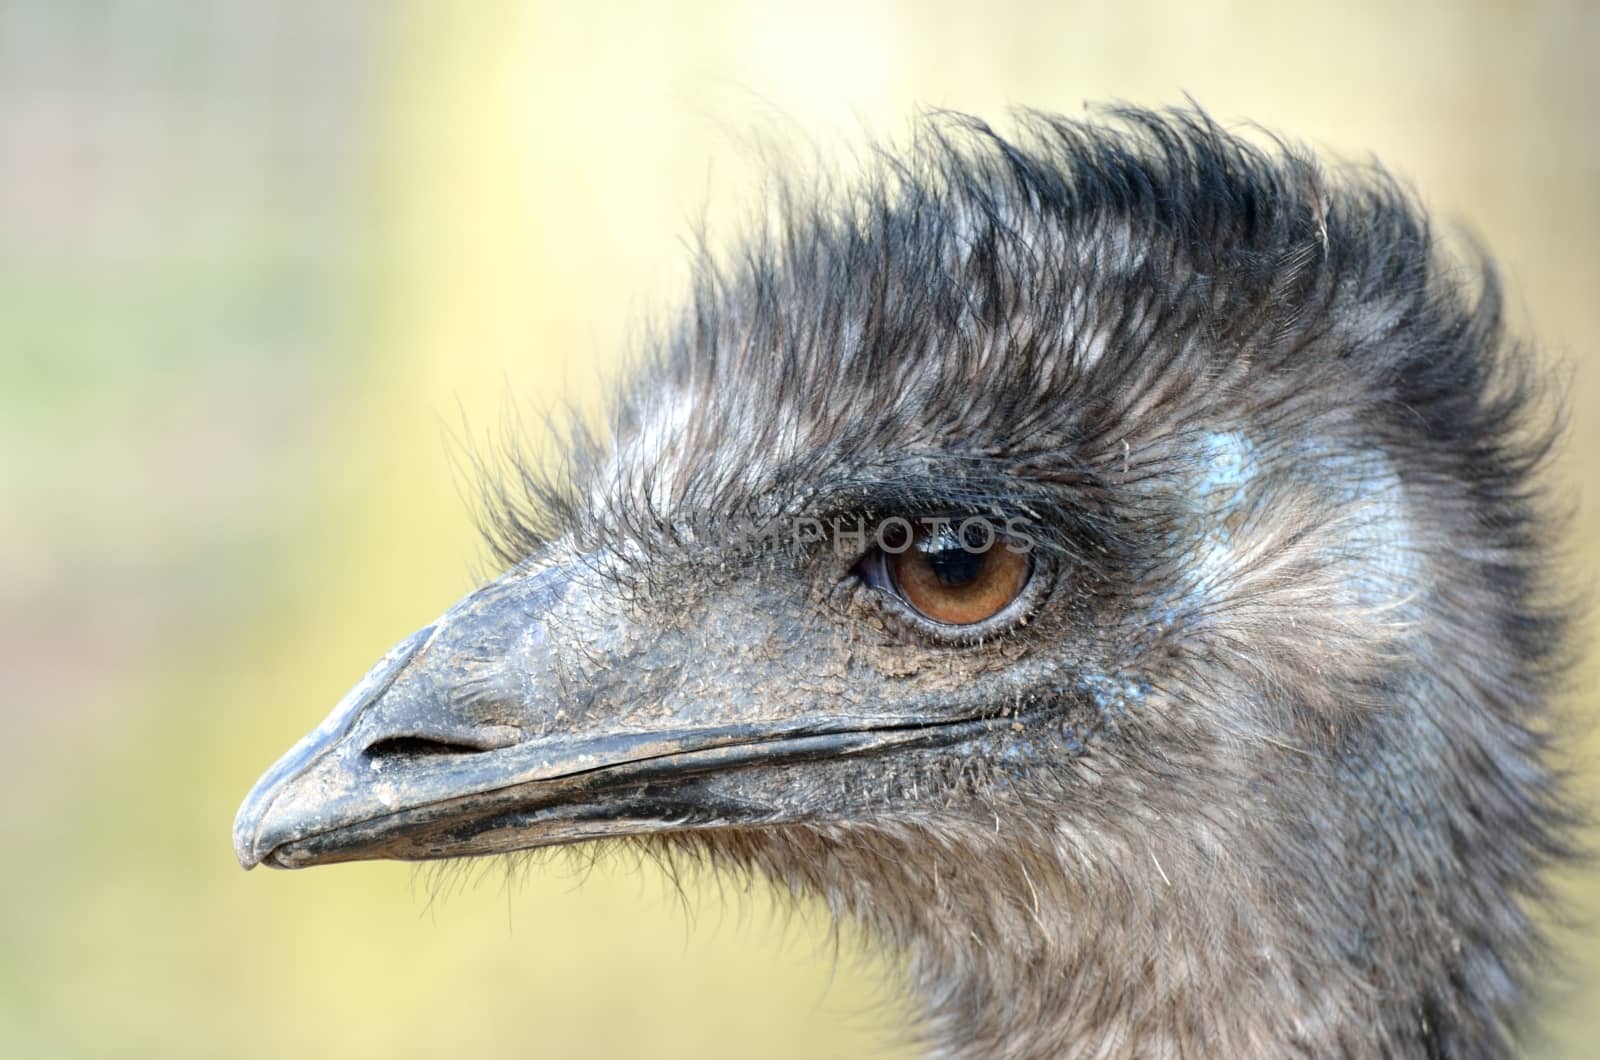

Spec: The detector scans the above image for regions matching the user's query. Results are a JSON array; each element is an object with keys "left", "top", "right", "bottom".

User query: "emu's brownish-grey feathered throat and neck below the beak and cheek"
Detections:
[{"left": 745, "top": 688, "right": 1539, "bottom": 1060}]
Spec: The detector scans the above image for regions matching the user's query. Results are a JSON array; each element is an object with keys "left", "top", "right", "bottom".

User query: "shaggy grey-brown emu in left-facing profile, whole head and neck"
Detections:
[{"left": 234, "top": 109, "right": 1574, "bottom": 1058}]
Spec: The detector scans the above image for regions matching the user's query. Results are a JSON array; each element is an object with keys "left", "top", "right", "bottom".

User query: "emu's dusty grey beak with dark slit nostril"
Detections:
[{"left": 234, "top": 567, "right": 987, "bottom": 868}]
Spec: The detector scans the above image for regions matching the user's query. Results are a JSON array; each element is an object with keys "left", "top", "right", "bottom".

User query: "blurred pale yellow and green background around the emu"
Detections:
[{"left": 0, "top": 0, "right": 1600, "bottom": 1058}]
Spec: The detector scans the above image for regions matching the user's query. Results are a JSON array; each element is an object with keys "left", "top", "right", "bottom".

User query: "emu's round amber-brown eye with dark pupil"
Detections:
[{"left": 886, "top": 520, "right": 1032, "bottom": 626}]
